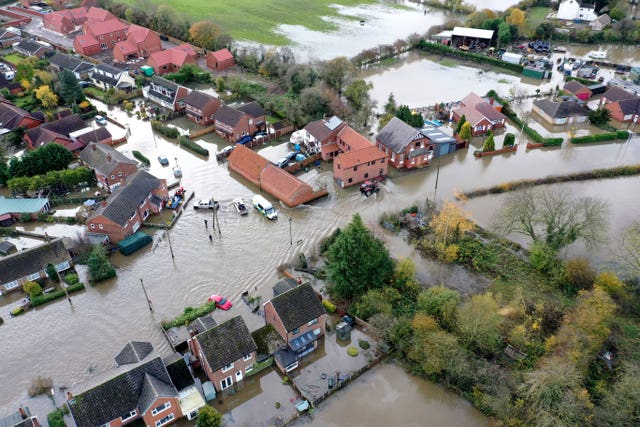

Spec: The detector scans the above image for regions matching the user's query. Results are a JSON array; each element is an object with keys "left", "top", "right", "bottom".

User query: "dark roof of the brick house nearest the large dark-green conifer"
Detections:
[{"left": 271, "top": 284, "right": 327, "bottom": 332}]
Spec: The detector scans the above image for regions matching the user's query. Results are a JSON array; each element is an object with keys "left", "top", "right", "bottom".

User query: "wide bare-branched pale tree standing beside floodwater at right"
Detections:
[{"left": 495, "top": 189, "right": 608, "bottom": 253}]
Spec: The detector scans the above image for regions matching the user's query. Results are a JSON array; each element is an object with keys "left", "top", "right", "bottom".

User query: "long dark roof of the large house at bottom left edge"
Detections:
[{"left": 67, "top": 357, "right": 177, "bottom": 427}]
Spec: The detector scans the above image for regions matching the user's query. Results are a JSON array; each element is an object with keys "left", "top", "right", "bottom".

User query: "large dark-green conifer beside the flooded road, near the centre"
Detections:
[{"left": 326, "top": 214, "right": 393, "bottom": 300}]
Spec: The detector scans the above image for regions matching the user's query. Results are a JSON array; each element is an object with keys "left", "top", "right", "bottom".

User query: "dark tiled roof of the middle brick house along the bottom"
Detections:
[{"left": 196, "top": 316, "right": 258, "bottom": 371}]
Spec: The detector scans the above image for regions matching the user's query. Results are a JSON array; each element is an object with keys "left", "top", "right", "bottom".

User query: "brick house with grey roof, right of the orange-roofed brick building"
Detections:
[{"left": 376, "top": 117, "right": 434, "bottom": 169}]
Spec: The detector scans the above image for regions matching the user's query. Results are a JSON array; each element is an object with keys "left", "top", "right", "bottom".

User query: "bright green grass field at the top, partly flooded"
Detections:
[{"left": 123, "top": 0, "right": 378, "bottom": 45}]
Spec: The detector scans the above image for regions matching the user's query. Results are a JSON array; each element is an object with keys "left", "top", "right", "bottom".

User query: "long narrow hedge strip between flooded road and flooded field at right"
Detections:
[{"left": 459, "top": 164, "right": 640, "bottom": 199}]
